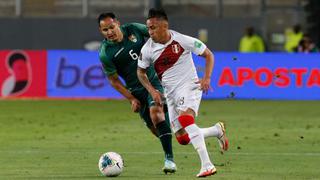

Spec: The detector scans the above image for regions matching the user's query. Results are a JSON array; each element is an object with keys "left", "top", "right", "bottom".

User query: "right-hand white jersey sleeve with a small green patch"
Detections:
[{"left": 181, "top": 35, "right": 207, "bottom": 55}]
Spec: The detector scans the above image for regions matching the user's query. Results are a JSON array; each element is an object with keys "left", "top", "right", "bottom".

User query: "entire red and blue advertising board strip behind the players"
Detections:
[{"left": 4, "top": 50, "right": 320, "bottom": 100}]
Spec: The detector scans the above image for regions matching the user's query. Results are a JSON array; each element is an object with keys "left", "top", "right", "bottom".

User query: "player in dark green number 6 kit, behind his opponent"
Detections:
[{"left": 98, "top": 13, "right": 177, "bottom": 174}]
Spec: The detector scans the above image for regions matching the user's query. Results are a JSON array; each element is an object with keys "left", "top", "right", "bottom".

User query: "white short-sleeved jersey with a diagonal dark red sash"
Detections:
[{"left": 138, "top": 30, "right": 206, "bottom": 93}]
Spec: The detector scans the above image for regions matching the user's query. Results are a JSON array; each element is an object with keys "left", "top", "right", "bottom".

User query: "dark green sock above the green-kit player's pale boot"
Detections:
[{"left": 156, "top": 121, "right": 173, "bottom": 161}]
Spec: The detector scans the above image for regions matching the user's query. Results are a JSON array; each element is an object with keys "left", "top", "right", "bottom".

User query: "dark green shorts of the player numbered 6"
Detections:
[{"left": 131, "top": 80, "right": 169, "bottom": 129}]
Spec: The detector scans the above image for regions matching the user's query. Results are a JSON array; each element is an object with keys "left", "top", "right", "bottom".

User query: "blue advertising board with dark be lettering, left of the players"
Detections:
[{"left": 47, "top": 50, "right": 122, "bottom": 98}]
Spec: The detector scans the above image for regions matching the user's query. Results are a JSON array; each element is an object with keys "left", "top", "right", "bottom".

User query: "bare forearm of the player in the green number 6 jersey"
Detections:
[{"left": 108, "top": 74, "right": 140, "bottom": 112}]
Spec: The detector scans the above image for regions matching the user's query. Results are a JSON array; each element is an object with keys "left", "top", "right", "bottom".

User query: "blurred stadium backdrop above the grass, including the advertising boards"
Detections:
[{"left": 0, "top": 0, "right": 320, "bottom": 100}]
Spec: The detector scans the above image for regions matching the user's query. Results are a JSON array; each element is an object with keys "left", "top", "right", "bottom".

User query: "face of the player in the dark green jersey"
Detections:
[{"left": 99, "top": 17, "right": 122, "bottom": 42}]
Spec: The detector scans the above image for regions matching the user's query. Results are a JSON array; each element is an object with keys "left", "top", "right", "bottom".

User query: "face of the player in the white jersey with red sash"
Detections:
[{"left": 147, "top": 18, "right": 168, "bottom": 43}]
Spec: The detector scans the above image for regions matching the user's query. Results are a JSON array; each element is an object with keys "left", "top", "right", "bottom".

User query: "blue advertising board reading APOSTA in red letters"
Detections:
[{"left": 194, "top": 53, "right": 320, "bottom": 100}]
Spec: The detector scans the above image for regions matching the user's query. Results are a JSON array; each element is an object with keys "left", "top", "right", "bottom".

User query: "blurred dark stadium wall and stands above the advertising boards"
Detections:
[{"left": 0, "top": 0, "right": 319, "bottom": 51}]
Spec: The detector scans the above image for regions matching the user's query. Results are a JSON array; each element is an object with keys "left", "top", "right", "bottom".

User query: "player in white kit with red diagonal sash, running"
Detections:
[{"left": 137, "top": 9, "right": 228, "bottom": 177}]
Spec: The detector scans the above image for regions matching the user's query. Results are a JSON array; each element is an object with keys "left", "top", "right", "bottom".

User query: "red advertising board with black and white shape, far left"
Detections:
[{"left": 0, "top": 50, "right": 47, "bottom": 98}]
